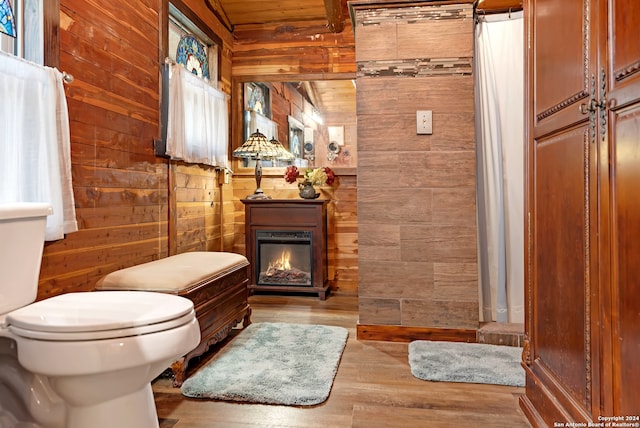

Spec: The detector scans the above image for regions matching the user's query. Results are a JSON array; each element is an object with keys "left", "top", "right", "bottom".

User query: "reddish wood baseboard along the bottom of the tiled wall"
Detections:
[{"left": 357, "top": 324, "right": 477, "bottom": 343}]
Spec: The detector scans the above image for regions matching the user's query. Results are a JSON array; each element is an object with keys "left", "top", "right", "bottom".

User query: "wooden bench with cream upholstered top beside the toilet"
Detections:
[{"left": 96, "top": 251, "right": 251, "bottom": 386}]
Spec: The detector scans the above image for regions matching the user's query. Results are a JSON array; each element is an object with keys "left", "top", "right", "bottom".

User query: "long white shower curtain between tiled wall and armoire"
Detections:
[{"left": 476, "top": 12, "right": 524, "bottom": 323}]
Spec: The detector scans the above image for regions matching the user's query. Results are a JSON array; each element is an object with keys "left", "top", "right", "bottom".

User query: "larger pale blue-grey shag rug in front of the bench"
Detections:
[{"left": 182, "top": 323, "right": 349, "bottom": 406}]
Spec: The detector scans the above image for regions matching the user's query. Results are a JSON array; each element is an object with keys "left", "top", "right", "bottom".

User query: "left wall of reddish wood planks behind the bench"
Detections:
[{"left": 38, "top": 0, "right": 233, "bottom": 299}]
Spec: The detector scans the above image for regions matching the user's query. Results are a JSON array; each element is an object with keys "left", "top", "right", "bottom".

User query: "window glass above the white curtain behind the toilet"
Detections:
[{"left": 0, "top": 0, "right": 44, "bottom": 65}]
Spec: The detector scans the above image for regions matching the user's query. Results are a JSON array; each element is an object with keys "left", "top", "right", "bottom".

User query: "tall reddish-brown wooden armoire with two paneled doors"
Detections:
[{"left": 520, "top": 0, "right": 640, "bottom": 427}]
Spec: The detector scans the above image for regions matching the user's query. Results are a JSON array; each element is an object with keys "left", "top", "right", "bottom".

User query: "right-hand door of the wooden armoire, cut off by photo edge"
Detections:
[{"left": 603, "top": 0, "right": 640, "bottom": 414}]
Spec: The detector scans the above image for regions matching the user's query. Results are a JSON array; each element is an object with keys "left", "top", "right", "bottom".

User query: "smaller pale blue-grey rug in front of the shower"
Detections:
[{"left": 409, "top": 340, "right": 525, "bottom": 386}]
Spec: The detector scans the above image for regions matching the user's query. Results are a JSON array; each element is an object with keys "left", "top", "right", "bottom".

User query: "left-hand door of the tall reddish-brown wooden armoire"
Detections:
[{"left": 521, "top": 0, "right": 606, "bottom": 426}]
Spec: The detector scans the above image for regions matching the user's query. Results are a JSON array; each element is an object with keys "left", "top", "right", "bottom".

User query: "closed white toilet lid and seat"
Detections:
[{"left": 6, "top": 291, "right": 193, "bottom": 340}]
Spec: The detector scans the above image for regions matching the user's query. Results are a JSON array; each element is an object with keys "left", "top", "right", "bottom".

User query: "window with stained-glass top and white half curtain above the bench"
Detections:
[{"left": 156, "top": 4, "right": 229, "bottom": 168}]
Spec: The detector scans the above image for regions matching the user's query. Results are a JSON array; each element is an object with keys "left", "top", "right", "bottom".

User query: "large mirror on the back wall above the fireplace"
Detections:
[{"left": 233, "top": 79, "right": 357, "bottom": 168}]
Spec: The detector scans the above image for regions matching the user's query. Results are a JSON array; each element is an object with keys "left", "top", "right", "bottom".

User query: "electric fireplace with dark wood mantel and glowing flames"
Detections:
[{"left": 242, "top": 199, "right": 329, "bottom": 300}]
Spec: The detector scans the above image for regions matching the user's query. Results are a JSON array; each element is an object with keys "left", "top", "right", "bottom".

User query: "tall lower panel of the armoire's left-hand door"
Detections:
[{"left": 533, "top": 128, "right": 590, "bottom": 406}]
